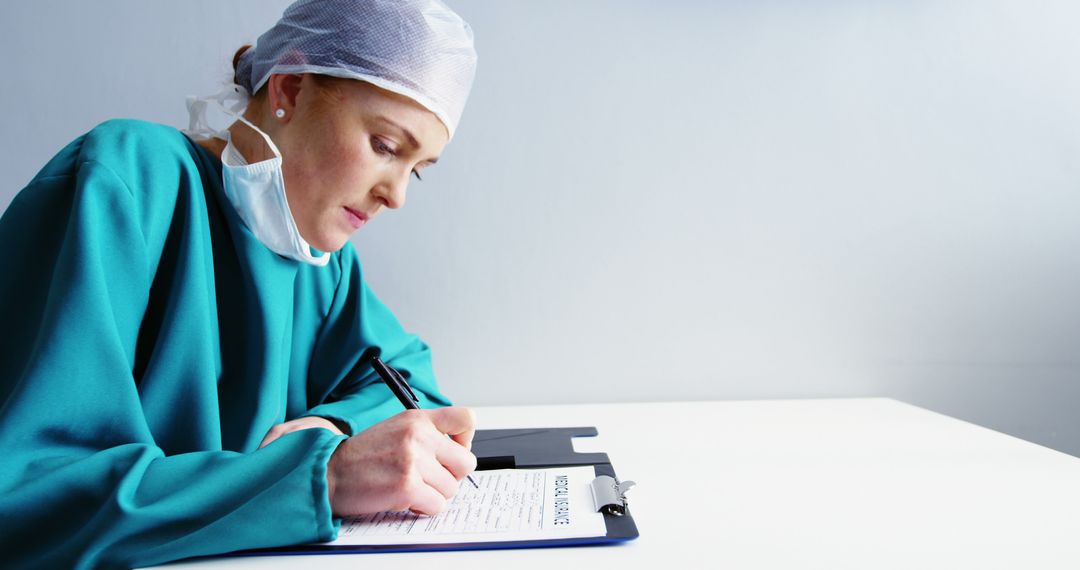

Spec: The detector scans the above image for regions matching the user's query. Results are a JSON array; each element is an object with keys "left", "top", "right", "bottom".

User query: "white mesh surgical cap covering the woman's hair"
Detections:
[{"left": 237, "top": 0, "right": 476, "bottom": 137}]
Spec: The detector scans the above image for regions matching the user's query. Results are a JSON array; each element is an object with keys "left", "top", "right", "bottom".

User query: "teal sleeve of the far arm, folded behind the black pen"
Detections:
[{"left": 307, "top": 245, "right": 450, "bottom": 434}]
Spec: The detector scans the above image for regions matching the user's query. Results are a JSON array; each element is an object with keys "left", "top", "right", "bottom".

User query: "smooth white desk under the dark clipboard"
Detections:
[{"left": 159, "top": 398, "right": 1080, "bottom": 570}]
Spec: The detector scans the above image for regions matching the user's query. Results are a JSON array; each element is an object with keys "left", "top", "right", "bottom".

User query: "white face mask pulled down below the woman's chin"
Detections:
[{"left": 187, "top": 86, "right": 330, "bottom": 267}]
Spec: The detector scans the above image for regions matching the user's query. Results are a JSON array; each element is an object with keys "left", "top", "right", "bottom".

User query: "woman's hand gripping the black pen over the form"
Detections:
[{"left": 326, "top": 408, "right": 476, "bottom": 516}]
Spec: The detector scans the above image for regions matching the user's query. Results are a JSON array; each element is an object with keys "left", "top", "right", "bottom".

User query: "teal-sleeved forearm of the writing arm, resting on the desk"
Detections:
[{"left": 0, "top": 430, "right": 343, "bottom": 568}]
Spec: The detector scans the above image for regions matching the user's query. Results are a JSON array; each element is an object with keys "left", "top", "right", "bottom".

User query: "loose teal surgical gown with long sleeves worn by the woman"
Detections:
[{"left": 0, "top": 120, "right": 449, "bottom": 568}]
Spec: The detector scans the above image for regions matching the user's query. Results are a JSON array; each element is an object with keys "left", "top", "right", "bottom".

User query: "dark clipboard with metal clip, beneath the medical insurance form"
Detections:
[{"left": 236, "top": 428, "right": 638, "bottom": 556}]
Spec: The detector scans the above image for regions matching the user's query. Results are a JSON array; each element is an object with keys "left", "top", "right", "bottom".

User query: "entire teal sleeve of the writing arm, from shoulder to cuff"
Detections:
[{"left": 0, "top": 163, "right": 343, "bottom": 568}]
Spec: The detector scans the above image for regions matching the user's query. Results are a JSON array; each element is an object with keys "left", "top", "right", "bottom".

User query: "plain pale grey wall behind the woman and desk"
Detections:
[{"left": 0, "top": 0, "right": 1080, "bottom": 453}]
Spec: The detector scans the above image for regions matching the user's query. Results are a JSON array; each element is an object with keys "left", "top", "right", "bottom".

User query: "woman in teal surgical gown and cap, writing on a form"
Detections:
[{"left": 0, "top": 0, "right": 476, "bottom": 568}]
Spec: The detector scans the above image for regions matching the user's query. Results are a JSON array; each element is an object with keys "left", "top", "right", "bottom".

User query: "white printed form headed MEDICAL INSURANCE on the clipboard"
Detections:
[{"left": 325, "top": 465, "right": 607, "bottom": 545}]
